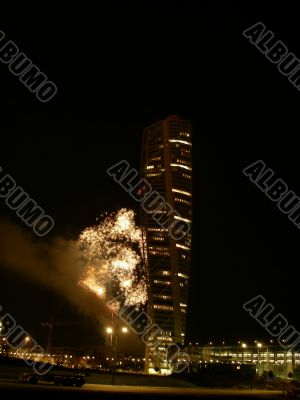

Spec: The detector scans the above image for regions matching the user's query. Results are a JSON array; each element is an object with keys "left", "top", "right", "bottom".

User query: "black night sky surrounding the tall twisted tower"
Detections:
[{"left": 0, "top": 0, "right": 300, "bottom": 344}]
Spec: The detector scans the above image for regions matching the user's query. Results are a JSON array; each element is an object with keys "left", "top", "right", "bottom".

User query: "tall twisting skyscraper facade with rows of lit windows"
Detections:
[{"left": 141, "top": 116, "right": 192, "bottom": 372}]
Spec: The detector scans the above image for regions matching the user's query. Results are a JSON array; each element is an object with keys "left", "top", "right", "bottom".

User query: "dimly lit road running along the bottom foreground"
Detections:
[{"left": 0, "top": 382, "right": 284, "bottom": 400}]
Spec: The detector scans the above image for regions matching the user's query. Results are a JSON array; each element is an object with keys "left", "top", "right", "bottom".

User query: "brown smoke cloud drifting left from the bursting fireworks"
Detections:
[{"left": 0, "top": 220, "right": 109, "bottom": 320}]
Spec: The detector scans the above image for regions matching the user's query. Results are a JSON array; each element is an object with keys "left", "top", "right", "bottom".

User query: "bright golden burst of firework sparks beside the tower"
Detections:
[{"left": 79, "top": 208, "right": 147, "bottom": 308}]
